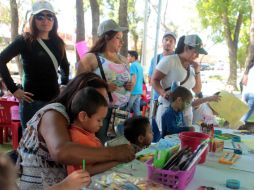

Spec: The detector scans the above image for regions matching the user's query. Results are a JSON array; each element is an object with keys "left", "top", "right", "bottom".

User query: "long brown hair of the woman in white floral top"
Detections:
[{"left": 89, "top": 31, "right": 117, "bottom": 53}]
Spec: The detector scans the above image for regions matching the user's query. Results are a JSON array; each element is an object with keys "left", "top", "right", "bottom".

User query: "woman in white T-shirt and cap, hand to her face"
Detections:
[{"left": 152, "top": 34, "right": 207, "bottom": 130}]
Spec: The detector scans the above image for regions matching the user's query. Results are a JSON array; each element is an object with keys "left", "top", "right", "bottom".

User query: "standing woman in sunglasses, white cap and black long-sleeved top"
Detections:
[{"left": 0, "top": 1, "right": 69, "bottom": 131}]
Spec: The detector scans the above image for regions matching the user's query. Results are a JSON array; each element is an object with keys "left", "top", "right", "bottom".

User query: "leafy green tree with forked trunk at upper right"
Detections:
[{"left": 197, "top": 0, "right": 250, "bottom": 89}]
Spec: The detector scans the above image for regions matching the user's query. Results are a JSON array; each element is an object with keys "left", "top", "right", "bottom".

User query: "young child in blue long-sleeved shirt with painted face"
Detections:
[{"left": 161, "top": 86, "right": 194, "bottom": 137}]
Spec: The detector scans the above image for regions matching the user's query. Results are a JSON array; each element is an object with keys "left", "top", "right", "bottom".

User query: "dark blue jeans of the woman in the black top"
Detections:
[{"left": 19, "top": 100, "right": 48, "bottom": 131}]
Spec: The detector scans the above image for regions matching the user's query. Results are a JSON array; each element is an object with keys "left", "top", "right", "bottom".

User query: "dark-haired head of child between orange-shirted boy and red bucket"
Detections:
[{"left": 124, "top": 116, "right": 153, "bottom": 152}]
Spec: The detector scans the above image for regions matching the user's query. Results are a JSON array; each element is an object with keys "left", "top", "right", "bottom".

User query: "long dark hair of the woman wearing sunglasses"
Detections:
[{"left": 23, "top": 13, "right": 65, "bottom": 58}]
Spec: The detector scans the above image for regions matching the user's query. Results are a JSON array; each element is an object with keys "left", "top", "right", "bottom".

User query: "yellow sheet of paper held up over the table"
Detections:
[{"left": 209, "top": 91, "right": 249, "bottom": 129}]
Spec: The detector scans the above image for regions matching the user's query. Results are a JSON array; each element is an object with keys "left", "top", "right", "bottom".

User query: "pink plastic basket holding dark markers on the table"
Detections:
[{"left": 146, "top": 159, "right": 196, "bottom": 190}]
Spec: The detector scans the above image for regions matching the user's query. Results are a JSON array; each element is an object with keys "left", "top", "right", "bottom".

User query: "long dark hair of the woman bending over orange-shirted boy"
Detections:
[{"left": 51, "top": 72, "right": 108, "bottom": 122}]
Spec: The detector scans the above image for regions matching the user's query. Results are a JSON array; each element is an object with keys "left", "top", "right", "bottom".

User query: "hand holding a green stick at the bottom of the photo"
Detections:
[{"left": 62, "top": 170, "right": 91, "bottom": 190}]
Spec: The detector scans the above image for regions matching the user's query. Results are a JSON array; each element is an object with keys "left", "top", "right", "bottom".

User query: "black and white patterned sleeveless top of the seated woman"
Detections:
[{"left": 18, "top": 103, "right": 69, "bottom": 190}]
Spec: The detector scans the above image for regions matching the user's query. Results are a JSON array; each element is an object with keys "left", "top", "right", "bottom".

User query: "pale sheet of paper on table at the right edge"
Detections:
[{"left": 230, "top": 155, "right": 254, "bottom": 173}]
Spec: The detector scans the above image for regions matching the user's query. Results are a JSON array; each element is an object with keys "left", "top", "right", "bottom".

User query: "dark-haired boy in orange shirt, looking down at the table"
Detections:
[{"left": 67, "top": 87, "right": 118, "bottom": 175}]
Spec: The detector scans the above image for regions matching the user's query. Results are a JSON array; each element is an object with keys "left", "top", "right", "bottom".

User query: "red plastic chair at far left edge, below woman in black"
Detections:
[{"left": 0, "top": 100, "right": 21, "bottom": 150}]
